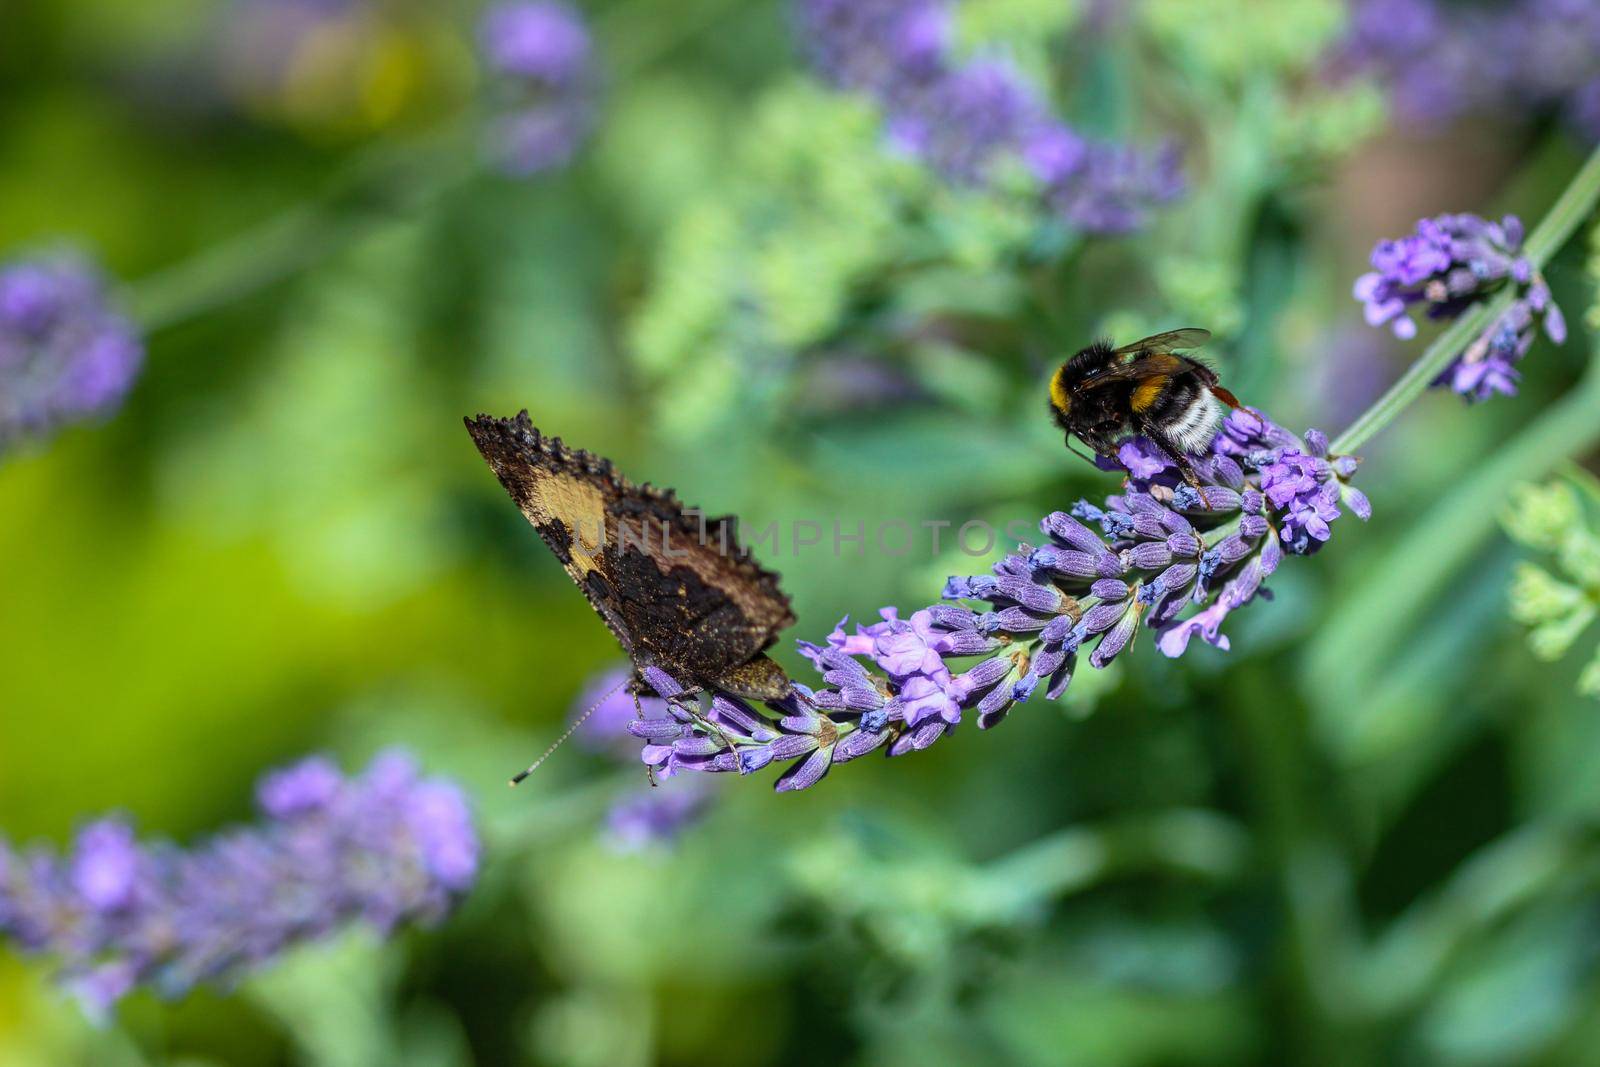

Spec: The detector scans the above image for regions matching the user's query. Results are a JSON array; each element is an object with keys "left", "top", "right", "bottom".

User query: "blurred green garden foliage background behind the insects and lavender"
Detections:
[{"left": 9, "top": 0, "right": 1600, "bottom": 1067}]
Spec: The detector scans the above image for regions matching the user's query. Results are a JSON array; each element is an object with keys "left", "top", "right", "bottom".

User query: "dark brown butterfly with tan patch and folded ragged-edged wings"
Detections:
[{"left": 466, "top": 411, "right": 795, "bottom": 701}]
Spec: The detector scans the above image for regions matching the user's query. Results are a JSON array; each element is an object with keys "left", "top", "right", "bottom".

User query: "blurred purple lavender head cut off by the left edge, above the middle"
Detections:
[{"left": 0, "top": 256, "right": 144, "bottom": 448}]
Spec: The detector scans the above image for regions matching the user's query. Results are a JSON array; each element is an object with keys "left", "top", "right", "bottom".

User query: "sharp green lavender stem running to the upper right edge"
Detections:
[{"left": 1333, "top": 147, "right": 1600, "bottom": 453}]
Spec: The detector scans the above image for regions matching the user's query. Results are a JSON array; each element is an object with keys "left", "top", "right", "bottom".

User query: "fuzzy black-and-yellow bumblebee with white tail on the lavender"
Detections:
[{"left": 1050, "top": 328, "right": 1238, "bottom": 482}]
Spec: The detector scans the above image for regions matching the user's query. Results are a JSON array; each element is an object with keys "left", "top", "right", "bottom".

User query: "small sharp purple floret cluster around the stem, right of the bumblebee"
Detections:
[{"left": 1355, "top": 214, "right": 1566, "bottom": 400}]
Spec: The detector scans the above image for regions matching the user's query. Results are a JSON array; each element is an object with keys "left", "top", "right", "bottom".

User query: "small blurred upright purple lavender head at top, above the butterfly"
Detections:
[{"left": 478, "top": 0, "right": 595, "bottom": 178}]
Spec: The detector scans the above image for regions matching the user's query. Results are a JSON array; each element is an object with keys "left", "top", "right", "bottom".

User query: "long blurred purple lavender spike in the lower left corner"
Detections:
[{"left": 0, "top": 752, "right": 478, "bottom": 1014}]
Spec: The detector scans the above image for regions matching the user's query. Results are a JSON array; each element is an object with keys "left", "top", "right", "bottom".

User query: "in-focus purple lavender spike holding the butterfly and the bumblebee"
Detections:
[{"left": 629, "top": 408, "right": 1371, "bottom": 792}]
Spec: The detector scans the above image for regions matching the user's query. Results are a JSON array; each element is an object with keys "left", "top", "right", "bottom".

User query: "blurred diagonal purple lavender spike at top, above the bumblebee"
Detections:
[{"left": 795, "top": 0, "right": 1182, "bottom": 234}]
